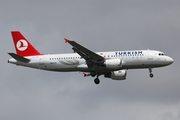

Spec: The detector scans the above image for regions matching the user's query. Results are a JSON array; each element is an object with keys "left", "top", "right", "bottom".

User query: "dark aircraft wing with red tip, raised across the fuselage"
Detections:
[{"left": 64, "top": 38, "right": 104, "bottom": 63}]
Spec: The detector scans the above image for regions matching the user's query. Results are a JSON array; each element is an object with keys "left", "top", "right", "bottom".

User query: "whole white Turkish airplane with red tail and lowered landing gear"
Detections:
[{"left": 8, "top": 31, "right": 173, "bottom": 84}]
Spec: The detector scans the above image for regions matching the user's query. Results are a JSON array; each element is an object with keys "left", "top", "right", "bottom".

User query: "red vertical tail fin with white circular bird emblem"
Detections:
[{"left": 11, "top": 31, "right": 42, "bottom": 57}]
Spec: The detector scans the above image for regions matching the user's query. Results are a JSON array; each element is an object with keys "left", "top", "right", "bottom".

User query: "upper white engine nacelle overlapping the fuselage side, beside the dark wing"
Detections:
[{"left": 104, "top": 59, "right": 122, "bottom": 70}]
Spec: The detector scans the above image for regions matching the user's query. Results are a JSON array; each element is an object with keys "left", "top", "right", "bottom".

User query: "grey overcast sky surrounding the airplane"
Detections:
[{"left": 0, "top": 0, "right": 180, "bottom": 120}]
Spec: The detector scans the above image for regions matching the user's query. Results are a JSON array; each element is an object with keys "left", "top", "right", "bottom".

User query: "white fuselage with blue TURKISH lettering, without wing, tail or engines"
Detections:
[{"left": 8, "top": 50, "right": 173, "bottom": 72}]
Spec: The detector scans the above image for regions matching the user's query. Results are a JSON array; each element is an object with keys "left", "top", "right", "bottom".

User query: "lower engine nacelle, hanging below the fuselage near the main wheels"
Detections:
[{"left": 104, "top": 70, "right": 127, "bottom": 80}]
